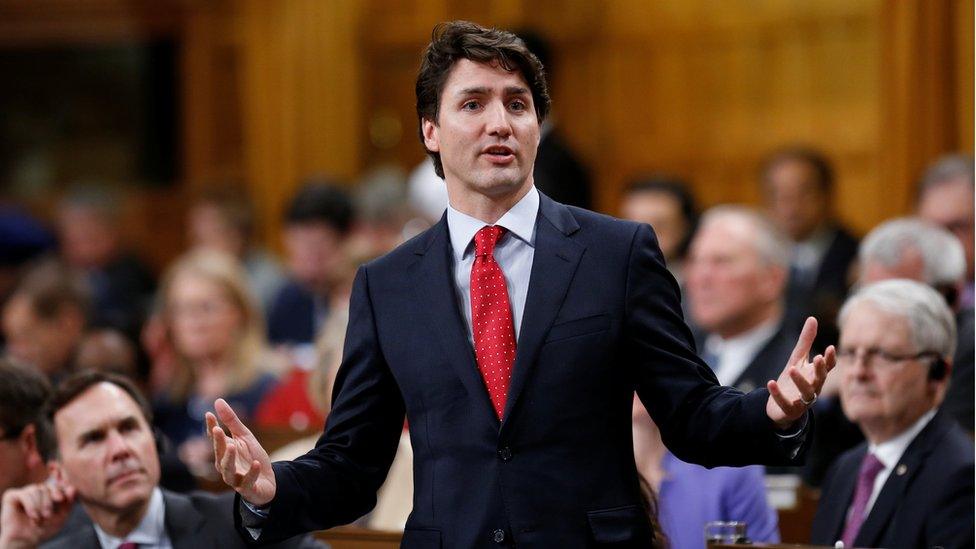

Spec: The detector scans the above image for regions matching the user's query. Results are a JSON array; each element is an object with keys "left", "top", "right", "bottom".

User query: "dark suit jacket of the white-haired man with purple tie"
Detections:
[{"left": 811, "top": 412, "right": 974, "bottom": 549}]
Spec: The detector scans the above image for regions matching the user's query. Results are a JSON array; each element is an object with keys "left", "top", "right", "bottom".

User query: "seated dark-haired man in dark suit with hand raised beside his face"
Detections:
[{"left": 0, "top": 372, "right": 322, "bottom": 549}]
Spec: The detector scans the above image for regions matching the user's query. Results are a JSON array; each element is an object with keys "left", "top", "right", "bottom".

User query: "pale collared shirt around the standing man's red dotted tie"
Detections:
[{"left": 447, "top": 187, "right": 539, "bottom": 345}]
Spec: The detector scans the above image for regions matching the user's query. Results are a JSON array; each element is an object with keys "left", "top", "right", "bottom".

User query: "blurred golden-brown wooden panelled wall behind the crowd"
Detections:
[{"left": 0, "top": 0, "right": 973, "bottom": 262}]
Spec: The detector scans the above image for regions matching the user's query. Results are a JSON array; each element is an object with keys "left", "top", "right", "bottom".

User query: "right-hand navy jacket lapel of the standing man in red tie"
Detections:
[{"left": 502, "top": 193, "right": 586, "bottom": 431}]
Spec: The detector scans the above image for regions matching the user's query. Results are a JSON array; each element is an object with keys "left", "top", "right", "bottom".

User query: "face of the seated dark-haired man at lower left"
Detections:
[{"left": 54, "top": 383, "right": 159, "bottom": 512}]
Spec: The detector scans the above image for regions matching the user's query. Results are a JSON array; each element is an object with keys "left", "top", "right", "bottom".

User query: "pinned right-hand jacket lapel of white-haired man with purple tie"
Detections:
[{"left": 854, "top": 414, "right": 947, "bottom": 547}]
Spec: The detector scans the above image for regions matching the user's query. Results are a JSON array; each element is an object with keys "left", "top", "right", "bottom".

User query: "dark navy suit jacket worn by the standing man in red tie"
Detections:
[{"left": 238, "top": 195, "right": 808, "bottom": 548}]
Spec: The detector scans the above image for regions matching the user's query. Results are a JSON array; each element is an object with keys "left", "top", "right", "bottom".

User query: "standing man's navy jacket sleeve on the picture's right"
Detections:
[{"left": 625, "top": 225, "right": 812, "bottom": 467}]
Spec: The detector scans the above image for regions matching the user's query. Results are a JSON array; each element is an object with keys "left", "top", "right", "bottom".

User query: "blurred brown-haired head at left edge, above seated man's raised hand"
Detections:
[{"left": 3, "top": 261, "right": 90, "bottom": 377}]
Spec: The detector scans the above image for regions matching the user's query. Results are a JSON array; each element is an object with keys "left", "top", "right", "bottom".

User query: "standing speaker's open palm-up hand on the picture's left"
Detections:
[{"left": 207, "top": 398, "right": 276, "bottom": 507}]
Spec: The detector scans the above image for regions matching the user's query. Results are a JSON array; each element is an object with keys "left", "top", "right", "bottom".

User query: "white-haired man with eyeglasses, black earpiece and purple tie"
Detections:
[{"left": 812, "top": 279, "right": 974, "bottom": 548}]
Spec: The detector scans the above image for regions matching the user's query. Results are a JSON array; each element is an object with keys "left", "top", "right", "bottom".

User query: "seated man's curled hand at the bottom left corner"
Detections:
[{"left": 0, "top": 478, "right": 75, "bottom": 549}]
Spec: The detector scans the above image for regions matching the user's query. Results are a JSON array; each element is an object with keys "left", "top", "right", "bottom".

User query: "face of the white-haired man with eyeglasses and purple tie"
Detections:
[{"left": 838, "top": 303, "right": 937, "bottom": 442}]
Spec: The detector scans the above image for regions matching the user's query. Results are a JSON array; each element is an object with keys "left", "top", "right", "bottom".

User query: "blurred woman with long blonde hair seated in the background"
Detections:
[{"left": 155, "top": 251, "right": 276, "bottom": 472}]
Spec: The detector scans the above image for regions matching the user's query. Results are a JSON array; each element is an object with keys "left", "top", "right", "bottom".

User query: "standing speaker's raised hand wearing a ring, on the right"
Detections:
[{"left": 766, "top": 317, "right": 837, "bottom": 429}]
